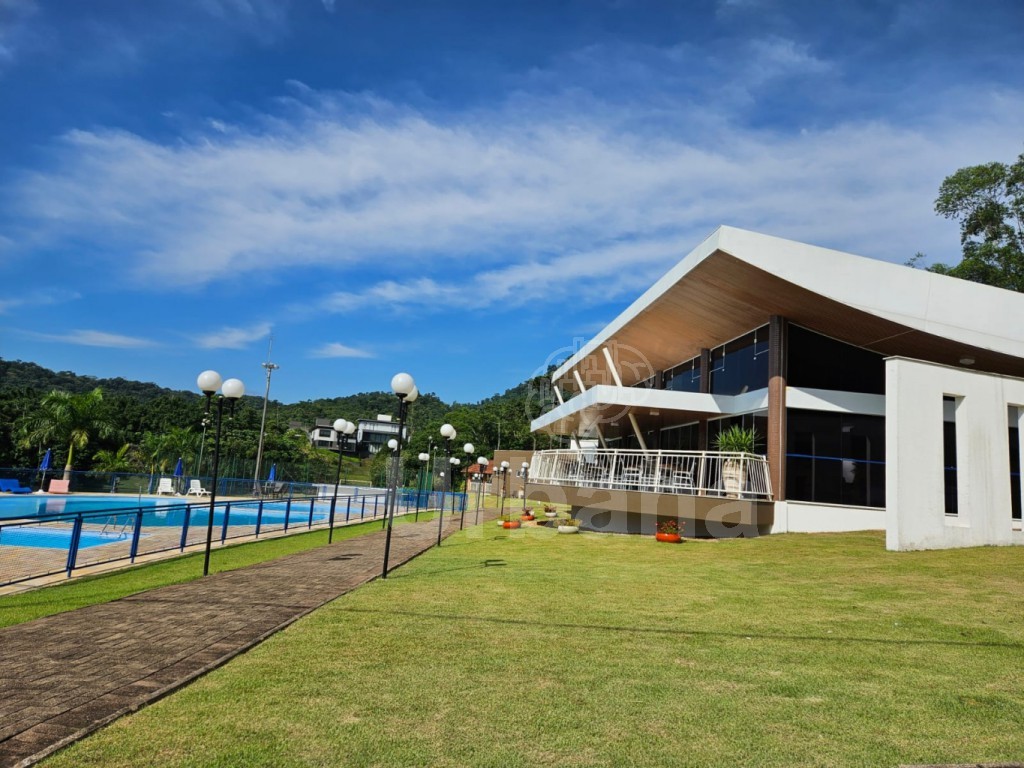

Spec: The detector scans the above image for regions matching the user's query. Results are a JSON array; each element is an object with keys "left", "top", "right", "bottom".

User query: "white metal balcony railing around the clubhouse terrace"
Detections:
[{"left": 529, "top": 449, "right": 771, "bottom": 500}]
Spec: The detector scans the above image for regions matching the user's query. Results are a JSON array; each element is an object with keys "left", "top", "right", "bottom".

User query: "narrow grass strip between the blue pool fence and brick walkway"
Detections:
[{"left": 0, "top": 512, "right": 432, "bottom": 627}]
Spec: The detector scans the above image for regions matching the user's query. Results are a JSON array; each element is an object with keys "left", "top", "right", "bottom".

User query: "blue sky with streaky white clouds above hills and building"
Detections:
[{"left": 0, "top": 0, "right": 1024, "bottom": 402}]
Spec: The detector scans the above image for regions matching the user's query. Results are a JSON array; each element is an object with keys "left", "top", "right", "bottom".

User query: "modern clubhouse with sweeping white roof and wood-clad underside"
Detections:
[{"left": 527, "top": 226, "right": 1024, "bottom": 549}]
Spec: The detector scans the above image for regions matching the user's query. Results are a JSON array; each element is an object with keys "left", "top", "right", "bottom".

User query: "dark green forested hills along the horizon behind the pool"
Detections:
[{"left": 0, "top": 360, "right": 553, "bottom": 476}]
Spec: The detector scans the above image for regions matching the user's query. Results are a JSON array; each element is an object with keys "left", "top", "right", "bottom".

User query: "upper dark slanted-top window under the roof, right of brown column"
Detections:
[{"left": 786, "top": 325, "right": 886, "bottom": 394}]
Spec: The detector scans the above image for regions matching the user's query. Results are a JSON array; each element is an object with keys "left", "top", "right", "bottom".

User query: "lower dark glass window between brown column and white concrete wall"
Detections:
[{"left": 785, "top": 409, "right": 886, "bottom": 507}]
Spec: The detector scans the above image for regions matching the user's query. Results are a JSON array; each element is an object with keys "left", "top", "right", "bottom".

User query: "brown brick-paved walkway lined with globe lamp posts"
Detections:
[{"left": 0, "top": 510, "right": 496, "bottom": 766}]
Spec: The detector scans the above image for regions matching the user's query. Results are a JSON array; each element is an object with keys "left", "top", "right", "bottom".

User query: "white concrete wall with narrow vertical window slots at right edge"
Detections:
[{"left": 886, "top": 357, "right": 1024, "bottom": 550}]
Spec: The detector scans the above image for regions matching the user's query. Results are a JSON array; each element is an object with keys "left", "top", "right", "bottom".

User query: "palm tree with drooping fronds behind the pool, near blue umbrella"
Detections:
[{"left": 22, "top": 387, "right": 114, "bottom": 480}]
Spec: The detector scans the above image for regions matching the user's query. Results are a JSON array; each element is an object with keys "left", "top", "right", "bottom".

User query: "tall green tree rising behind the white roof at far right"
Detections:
[{"left": 929, "top": 154, "right": 1024, "bottom": 292}]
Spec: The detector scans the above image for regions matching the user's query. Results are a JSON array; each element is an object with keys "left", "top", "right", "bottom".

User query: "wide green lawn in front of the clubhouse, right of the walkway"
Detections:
[{"left": 39, "top": 523, "right": 1024, "bottom": 767}]
